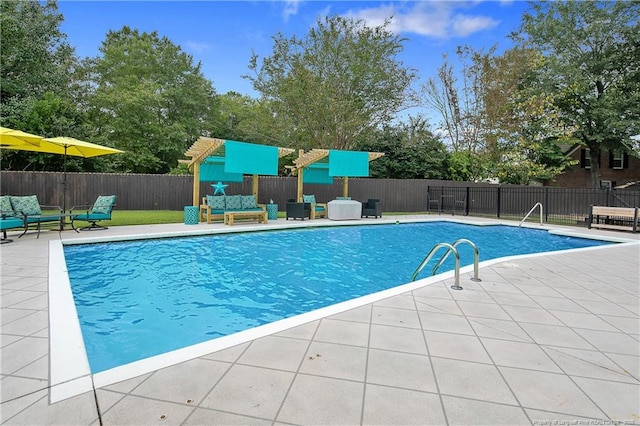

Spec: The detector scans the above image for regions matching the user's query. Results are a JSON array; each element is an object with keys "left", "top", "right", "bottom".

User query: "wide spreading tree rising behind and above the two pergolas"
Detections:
[{"left": 244, "top": 16, "right": 414, "bottom": 149}]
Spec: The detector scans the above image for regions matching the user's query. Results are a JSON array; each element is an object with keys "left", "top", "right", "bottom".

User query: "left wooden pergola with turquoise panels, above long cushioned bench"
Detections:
[{"left": 180, "top": 136, "right": 294, "bottom": 206}]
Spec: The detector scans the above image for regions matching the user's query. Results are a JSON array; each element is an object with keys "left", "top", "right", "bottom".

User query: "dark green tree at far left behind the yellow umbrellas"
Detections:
[{"left": 0, "top": 0, "right": 85, "bottom": 170}]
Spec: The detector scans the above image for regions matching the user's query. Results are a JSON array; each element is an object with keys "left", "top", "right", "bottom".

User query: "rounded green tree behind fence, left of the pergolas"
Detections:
[{"left": 84, "top": 26, "right": 220, "bottom": 173}]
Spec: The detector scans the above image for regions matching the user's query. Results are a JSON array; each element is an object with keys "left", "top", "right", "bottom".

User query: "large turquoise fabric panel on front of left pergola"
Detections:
[{"left": 225, "top": 141, "right": 279, "bottom": 174}]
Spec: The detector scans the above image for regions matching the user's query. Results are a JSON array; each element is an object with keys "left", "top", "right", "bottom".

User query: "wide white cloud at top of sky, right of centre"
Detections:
[{"left": 348, "top": 1, "right": 500, "bottom": 39}]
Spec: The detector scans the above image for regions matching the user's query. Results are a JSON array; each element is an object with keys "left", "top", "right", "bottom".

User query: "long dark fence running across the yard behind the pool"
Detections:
[{"left": 0, "top": 171, "right": 640, "bottom": 225}]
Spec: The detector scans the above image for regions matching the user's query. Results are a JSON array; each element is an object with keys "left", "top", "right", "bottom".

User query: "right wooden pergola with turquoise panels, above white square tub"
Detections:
[{"left": 287, "top": 149, "right": 384, "bottom": 202}]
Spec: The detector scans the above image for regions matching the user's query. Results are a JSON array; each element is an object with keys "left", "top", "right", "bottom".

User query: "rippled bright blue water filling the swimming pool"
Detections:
[{"left": 64, "top": 222, "right": 609, "bottom": 373}]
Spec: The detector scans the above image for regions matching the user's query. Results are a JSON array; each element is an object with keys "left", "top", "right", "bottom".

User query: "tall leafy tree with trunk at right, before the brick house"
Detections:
[{"left": 512, "top": 1, "right": 640, "bottom": 188}]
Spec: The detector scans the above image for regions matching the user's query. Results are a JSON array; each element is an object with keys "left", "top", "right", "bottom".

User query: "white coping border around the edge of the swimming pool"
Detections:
[{"left": 49, "top": 218, "right": 640, "bottom": 403}]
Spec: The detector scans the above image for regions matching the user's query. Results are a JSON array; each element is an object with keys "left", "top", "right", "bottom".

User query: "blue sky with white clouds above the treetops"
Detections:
[{"left": 58, "top": 0, "right": 528, "bottom": 115}]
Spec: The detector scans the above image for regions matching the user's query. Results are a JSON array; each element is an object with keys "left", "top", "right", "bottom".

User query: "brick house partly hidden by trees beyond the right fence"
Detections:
[{"left": 551, "top": 145, "right": 640, "bottom": 188}]
